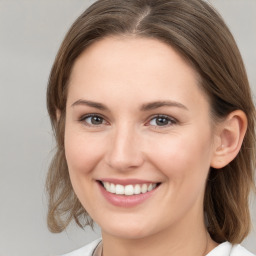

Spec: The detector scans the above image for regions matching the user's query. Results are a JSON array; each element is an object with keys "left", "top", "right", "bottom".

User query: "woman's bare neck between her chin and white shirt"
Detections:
[{"left": 102, "top": 213, "right": 217, "bottom": 256}]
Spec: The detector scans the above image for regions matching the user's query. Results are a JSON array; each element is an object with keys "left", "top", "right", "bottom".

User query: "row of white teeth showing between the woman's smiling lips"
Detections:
[{"left": 103, "top": 182, "right": 157, "bottom": 196}]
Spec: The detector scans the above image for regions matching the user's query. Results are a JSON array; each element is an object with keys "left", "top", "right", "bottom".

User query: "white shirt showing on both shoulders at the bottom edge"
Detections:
[{"left": 62, "top": 239, "right": 256, "bottom": 256}]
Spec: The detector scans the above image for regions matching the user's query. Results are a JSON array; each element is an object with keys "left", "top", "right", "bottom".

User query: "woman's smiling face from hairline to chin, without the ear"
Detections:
[{"left": 65, "top": 37, "right": 217, "bottom": 238}]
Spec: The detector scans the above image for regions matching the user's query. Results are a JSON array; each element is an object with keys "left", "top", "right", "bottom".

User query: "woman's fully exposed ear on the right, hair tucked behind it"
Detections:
[{"left": 211, "top": 110, "right": 247, "bottom": 169}]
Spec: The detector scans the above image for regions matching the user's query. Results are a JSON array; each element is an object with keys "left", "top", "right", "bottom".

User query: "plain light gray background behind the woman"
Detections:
[{"left": 0, "top": 0, "right": 256, "bottom": 256}]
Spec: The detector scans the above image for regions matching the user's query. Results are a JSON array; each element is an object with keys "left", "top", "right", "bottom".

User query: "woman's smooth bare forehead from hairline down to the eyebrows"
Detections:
[{"left": 68, "top": 37, "right": 206, "bottom": 113}]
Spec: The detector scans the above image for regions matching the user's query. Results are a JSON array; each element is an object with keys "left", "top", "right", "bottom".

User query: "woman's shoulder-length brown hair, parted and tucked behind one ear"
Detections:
[{"left": 46, "top": 0, "right": 255, "bottom": 243}]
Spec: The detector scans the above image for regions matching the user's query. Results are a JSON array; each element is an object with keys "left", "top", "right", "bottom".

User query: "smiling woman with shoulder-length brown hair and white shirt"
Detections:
[{"left": 47, "top": 0, "right": 255, "bottom": 256}]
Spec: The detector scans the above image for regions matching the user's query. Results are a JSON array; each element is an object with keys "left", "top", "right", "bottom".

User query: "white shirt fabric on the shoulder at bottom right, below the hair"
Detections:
[{"left": 206, "top": 242, "right": 255, "bottom": 256}]
